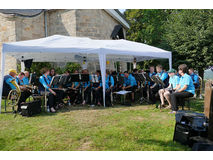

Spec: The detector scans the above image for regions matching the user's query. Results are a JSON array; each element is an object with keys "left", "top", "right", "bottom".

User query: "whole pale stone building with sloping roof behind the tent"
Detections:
[{"left": 0, "top": 9, "right": 129, "bottom": 73}]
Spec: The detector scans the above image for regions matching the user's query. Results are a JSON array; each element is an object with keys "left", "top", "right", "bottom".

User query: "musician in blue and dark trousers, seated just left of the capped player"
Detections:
[{"left": 150, "top": 65, "right": 169, "bottom": 104}]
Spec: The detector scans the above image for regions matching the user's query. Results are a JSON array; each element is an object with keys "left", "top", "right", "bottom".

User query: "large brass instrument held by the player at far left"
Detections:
[{"left": 7, "top": 79, "right": 21, "bottom": 110}]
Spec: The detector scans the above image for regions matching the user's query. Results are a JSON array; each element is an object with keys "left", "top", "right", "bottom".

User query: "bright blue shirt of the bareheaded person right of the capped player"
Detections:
[{"left": 179, "top": 73, "right": 195, "bottom": 94}]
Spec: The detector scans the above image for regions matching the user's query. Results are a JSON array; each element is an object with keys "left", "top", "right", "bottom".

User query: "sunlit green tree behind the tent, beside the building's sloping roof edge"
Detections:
[{"left": 124, "top": 9, "right": 171, "bottom": 68}]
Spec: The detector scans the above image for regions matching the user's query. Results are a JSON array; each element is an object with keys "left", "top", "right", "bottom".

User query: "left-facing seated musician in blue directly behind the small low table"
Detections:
[{"left": 122, "top": 71, "right": 137, "bottom": 102}]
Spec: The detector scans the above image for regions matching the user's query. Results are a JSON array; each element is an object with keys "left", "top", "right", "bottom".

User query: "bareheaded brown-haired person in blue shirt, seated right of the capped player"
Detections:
[{"left": 170, "top": 64, "right": 195, "bottom": 113}]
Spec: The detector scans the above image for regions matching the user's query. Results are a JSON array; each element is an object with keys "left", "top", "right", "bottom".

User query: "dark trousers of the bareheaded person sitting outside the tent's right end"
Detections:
[{"left": 171, "top": 91, "right": 193, "bottom": 111}]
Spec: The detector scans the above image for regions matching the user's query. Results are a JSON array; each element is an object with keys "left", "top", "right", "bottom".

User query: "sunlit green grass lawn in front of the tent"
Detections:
[{"left": 0, "top": 100, "right": 203, "bottom": 151}]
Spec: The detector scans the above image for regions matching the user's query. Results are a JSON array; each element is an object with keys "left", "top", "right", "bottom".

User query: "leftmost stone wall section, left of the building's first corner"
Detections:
[{"left": 0, "top": 13, "right": 17, "bottom": 78}]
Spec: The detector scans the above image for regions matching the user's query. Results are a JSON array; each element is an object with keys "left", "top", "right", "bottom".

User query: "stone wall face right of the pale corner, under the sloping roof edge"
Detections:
[{"left": 76, "top": 9, "right": 127, "bottom": 71}]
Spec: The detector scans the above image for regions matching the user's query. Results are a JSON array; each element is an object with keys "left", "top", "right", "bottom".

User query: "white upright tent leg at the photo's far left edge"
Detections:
[{"left": 0, "top": 49, "right": 5, "bottom": 113}]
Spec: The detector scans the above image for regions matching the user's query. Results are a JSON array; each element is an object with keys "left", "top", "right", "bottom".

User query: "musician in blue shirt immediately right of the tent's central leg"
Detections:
[{"left": 105, "top": 71, "right": 114, "bottom": 107}]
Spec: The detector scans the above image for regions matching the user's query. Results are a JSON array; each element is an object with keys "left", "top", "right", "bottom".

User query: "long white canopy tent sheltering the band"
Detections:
[{"left": 0, "top": 35, "right": 172, "bottom": 111}]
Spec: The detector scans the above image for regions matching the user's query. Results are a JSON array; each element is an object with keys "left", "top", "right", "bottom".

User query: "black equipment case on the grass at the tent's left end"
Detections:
[{"left": 21, "top": 100, "right": 41, "bottom": 117}]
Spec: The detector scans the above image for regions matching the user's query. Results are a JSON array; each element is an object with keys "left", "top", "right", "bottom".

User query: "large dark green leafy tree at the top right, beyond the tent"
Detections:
[{"left": 163, "top": 10, "right": 213, "bottom": 76}]
